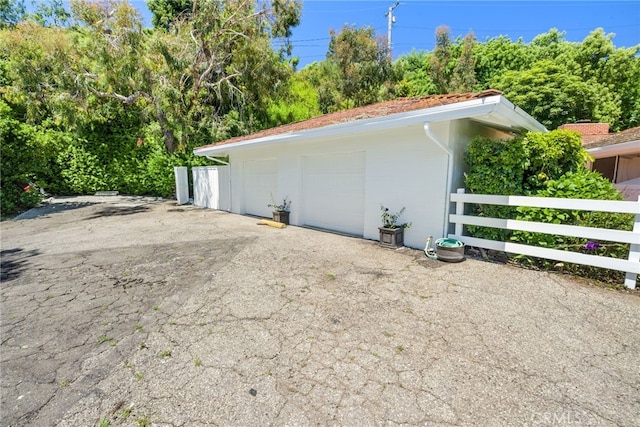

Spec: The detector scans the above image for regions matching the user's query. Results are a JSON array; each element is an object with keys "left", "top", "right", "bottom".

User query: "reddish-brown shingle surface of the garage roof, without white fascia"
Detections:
[{"left": 197, "top": 89, "right": 502, "bottom": 149}]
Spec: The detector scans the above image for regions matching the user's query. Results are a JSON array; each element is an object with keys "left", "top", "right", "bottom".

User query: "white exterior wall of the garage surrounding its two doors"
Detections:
[{"left": 218, "top": 120, "right": 505, "bottom": 249}]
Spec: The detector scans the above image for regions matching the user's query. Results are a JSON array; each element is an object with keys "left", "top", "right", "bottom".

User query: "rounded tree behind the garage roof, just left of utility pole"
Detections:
[{"left": 327, "top": 25, "right": 392, "bottom": 106}]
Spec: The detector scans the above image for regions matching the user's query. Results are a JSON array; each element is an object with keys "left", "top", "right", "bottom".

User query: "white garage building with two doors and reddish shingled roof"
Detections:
[{"left": 194, "top": 90, "right": 546, "bottom": 248}]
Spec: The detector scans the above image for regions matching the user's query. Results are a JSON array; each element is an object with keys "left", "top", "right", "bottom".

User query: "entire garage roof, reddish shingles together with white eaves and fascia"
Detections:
[{"left": 194, "top": 89, "right": 546, "bottom": 156}]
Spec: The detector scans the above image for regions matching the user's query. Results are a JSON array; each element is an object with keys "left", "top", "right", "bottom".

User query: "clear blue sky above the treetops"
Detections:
[{"left": 130, "top": 0, "right": 640, "bottom": 68}]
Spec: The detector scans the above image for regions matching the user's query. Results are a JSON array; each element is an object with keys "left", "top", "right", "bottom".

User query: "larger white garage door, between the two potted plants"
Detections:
[{"left": 302, "top": 152, "right": 365, "bottom": 236}]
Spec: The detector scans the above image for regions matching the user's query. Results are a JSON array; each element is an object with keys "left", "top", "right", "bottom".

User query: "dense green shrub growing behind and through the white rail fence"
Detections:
[{"left": 466, "top": 131, "right": 633, "bottom": 283}]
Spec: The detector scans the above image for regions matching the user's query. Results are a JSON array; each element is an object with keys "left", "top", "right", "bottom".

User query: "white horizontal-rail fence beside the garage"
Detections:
[{"left": 449, "top": 189, "right": 640, "bottom": 289}]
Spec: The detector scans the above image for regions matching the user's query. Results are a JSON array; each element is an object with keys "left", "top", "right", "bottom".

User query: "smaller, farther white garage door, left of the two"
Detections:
[{"left": 243, "top": 159, "right": 278, "bottom": 218}]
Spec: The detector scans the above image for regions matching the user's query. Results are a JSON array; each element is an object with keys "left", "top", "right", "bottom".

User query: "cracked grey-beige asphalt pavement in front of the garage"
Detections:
[{"left": 0, "top": 197, "right": 640, "bottom": 426}]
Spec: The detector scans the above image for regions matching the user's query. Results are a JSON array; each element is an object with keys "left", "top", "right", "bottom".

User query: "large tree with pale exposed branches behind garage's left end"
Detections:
[{"left": 67, "top": 0, "right": 300, "bottom": 152}]
